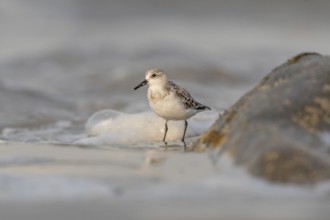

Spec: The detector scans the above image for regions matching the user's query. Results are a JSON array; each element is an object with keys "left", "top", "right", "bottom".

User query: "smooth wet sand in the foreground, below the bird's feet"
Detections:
[{"left": 0, "top": 143, "right": 330, "bottom": 220}]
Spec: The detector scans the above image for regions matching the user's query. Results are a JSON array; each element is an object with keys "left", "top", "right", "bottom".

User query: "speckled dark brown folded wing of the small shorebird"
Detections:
[{"left": 167, "top": 81, "right": 211, "bottom": 111}]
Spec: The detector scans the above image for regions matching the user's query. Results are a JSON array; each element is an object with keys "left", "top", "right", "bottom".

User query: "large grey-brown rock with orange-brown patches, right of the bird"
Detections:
[{"left": 193, "top": 53, "right": 330, "bottom": 184}]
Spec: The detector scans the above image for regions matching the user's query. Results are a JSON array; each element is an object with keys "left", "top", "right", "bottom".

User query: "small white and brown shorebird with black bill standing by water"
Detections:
[{"left": 134, "top": 69, "right": 211, "bottom": 146}]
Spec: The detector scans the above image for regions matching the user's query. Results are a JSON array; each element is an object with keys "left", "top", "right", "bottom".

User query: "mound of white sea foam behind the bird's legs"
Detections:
[{"left": 76, "top": 109, "right": 218, "bottom": 145}]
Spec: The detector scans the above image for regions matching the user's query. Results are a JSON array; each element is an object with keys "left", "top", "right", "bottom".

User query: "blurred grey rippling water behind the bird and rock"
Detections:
[{"left": 0, "top": 0, "right": 330, "bottom": 141}]
